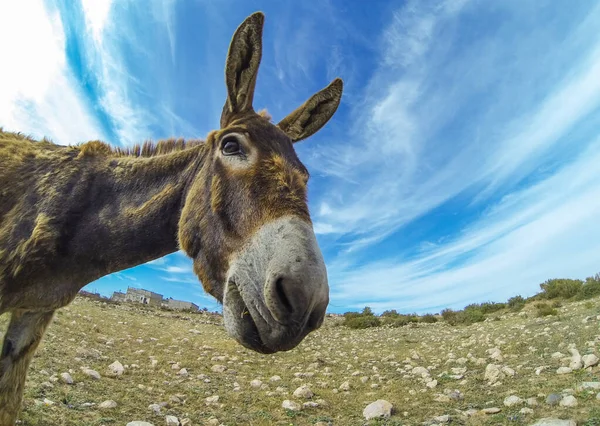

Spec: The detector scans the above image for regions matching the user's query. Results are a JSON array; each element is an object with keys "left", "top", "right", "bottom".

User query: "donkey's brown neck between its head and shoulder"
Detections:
[{"left": 72, "top": 145, "right": 206, "bottom": 282}]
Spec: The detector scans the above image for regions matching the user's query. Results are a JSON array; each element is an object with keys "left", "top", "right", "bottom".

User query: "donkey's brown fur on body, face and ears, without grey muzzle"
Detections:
[{"left": 0, "top": 13, "right": 341, "bottom": 426}]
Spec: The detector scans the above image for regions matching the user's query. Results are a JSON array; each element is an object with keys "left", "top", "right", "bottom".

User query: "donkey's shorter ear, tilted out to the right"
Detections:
[{"left": 277, "top": 78, "right": 344, "bottom": 142}]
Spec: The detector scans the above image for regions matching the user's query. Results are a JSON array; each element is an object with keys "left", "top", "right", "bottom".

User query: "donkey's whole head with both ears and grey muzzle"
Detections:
[{"left": 179, "top": 13, "right": 342, "bottom": 353}]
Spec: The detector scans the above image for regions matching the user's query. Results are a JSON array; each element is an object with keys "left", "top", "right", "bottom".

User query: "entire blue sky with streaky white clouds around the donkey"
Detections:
[{"left": 0, "top": 0, "right": 600, "bottom": 312}]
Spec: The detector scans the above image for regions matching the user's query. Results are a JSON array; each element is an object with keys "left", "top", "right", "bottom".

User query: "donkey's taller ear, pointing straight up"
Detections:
[{"left": 221, "top": 12, "right": 265, "bottom": 128}]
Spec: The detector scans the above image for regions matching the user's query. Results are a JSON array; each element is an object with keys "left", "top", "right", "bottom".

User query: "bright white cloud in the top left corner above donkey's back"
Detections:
[{"left": 0, "top": 0, "right": 103, "bottom": 144}]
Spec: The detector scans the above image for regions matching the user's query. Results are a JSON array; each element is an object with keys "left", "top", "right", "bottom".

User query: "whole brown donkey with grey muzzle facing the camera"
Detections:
[{"left": 0, "top": 12, "right": 343, "bottom": 426}]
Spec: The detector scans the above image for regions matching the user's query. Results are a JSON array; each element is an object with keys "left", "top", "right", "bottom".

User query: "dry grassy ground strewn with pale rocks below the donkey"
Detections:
[{"left": 0, "top": 298, "right": 600, "bottom": 426}]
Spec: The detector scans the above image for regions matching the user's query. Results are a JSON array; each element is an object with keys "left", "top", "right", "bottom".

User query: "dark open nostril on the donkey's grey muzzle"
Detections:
[{"left": 265, "top": 273, "right": 312, "bottom": 324}]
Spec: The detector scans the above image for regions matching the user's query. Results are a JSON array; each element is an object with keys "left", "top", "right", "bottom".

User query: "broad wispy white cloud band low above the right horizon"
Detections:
[{"left": 329, "top": 140, "right": 600, "bottom": 312}]
